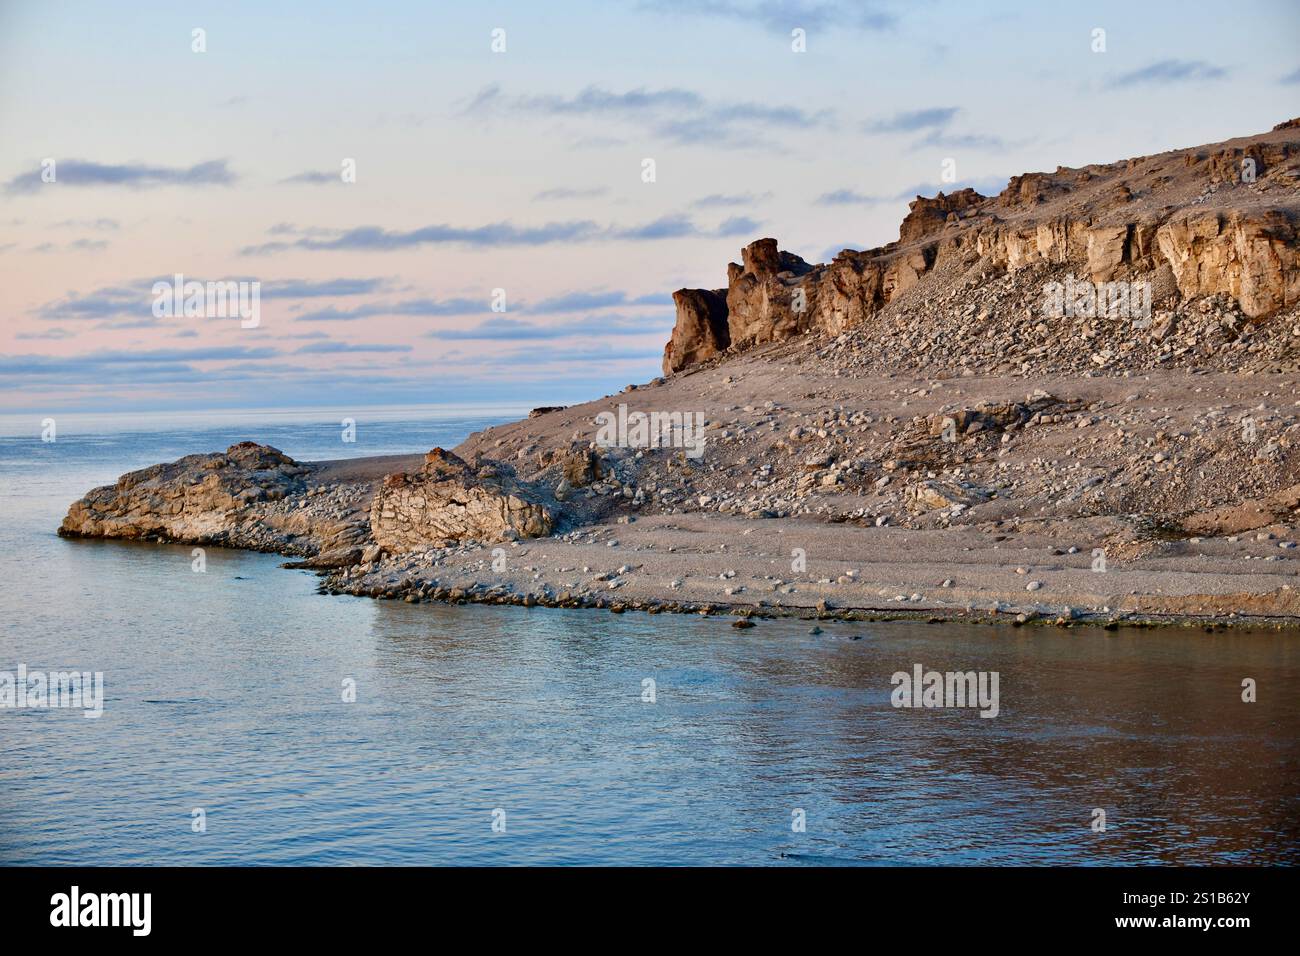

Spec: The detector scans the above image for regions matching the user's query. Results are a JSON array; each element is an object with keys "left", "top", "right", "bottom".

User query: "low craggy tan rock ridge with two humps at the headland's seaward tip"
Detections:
[{"left": 59, "top": 442, "right": 559, "bottom": 567}]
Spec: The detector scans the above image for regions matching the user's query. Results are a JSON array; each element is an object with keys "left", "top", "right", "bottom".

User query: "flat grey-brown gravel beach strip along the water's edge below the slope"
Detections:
[{"left": 299, "top": 515, "right": 1300, "bottom": 630}]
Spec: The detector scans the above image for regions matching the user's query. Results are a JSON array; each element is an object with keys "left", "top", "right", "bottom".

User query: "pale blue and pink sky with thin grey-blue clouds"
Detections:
[{"left": 0, "top": 0, "right": 1300, "bottom": 415}]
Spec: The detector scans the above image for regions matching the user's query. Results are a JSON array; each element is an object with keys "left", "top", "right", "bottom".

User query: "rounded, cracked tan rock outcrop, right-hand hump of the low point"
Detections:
[{"left": 371, "top": 447, "right": 555, "bottom": 553}]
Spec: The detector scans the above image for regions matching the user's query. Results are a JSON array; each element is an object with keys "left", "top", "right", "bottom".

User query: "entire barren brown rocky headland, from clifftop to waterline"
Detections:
[{"left": 60, "top": 121, "right": 1300, "bottom": 626}]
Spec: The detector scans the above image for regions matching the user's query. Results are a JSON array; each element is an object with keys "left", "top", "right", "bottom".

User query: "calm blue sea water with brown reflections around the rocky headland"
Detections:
[{"left": 0, "top": 408, "right": 1300, "bottom": 865}]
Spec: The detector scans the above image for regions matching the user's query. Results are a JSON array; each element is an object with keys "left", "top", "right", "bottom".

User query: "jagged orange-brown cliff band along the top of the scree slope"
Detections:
[{"left": 663, "top": 121, "right": 1300, "bottom": 375}]
